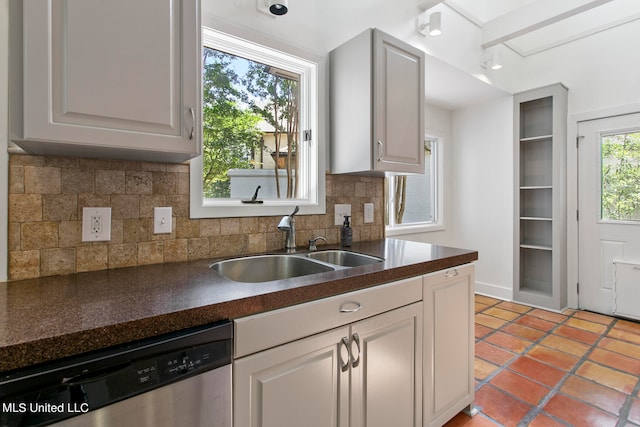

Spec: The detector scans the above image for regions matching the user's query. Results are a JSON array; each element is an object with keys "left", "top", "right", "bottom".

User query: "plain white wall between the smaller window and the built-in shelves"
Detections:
[{"left": 395, "top": 96, "right": 514, "bottom": 299}]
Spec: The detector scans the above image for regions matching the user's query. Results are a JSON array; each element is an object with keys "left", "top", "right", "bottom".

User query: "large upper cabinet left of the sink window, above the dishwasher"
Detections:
[{"left": 11, "top": 0, "right": 201, "bottom": 162}]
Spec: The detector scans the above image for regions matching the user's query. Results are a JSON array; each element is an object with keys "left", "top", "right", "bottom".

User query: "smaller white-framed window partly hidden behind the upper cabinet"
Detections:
[{"left": 385, "top": 138, "right": 442, "bottom": 235}]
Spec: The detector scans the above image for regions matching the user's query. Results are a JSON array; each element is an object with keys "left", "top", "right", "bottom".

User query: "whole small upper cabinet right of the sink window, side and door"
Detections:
[{"left": 330, "top": 29, "right": 425, "bottom": 175}]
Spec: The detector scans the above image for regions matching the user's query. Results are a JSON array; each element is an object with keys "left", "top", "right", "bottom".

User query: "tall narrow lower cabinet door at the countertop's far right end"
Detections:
[{"left": 423, "top": 265, "right": 475, "bottom": 426}]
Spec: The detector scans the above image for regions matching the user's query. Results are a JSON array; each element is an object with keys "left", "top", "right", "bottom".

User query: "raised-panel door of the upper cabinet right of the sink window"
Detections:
[{"left": 373, "top": 31, "right": 425, "bottom": 173}]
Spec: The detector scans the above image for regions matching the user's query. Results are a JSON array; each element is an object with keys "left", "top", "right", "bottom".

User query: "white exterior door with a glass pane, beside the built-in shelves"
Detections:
[{"left": 578, "top": 114, "right": 640, "bottom": 317}]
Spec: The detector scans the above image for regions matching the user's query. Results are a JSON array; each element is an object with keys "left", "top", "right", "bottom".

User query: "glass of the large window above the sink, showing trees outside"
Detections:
[{"left": 202, "top": 47, "right": 300, "bottom": 199}]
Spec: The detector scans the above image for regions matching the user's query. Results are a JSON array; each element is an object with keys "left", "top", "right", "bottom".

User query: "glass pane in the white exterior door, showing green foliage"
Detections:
[{"left": 600, "top": 132, "right": 640, "bottom": 221}]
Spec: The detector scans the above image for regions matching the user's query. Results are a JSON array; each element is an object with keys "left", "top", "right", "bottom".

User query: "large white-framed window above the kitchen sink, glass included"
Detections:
[{"left": 191, "top": 28, "right": 325, "bottom": 218}]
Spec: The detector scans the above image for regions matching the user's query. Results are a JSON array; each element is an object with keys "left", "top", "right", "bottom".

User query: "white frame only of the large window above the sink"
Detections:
[{"left": 189, "top": 25, "right": 326, "bottom": 218}]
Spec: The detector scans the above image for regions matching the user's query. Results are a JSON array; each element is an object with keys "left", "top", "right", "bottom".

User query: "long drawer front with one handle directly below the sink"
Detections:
[{"left": 234, "top": 277, "right": 422, "bottom": 358}]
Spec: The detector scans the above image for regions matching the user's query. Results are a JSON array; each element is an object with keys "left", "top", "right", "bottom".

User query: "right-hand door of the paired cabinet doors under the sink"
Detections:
[{"left": 350, "top": 302, "right": 422, "bottom": 427}]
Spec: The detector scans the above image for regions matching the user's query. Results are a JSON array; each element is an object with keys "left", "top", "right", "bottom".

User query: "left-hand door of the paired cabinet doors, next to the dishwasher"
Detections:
[{"left": 233, "top": 327, "right": 349, "bottom": 427}]
